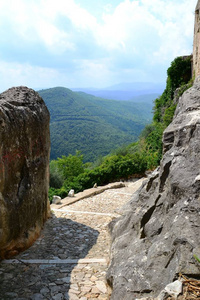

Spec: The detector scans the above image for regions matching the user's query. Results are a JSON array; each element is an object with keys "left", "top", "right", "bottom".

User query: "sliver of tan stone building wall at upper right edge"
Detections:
[{"left": 193, "top": 0, "right": 200, "bottom": 77}]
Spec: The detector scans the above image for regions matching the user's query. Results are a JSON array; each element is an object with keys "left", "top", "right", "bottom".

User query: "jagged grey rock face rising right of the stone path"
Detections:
[{"left": 107, "top": 80, "right": 200, "bottom": 300}]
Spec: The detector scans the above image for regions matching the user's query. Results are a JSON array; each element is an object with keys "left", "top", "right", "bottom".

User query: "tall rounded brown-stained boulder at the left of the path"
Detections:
[{"left": 0, "top": 87, "right": 50, "bottom": 258}]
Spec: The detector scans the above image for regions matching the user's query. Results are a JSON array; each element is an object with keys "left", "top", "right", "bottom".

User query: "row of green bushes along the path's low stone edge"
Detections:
[{"left": 49, "top": 149, "right": 147, "bottom": 200}]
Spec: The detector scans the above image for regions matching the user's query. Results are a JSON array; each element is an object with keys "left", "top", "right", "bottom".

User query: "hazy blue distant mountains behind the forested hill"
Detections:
[{"left": 72, "top": 82, "right": 165, "bottom": 102}]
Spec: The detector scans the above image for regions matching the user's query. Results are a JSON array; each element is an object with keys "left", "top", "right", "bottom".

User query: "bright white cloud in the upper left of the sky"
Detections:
[{"left": 0, "top": 0, "right": 95, "bottom": 53}]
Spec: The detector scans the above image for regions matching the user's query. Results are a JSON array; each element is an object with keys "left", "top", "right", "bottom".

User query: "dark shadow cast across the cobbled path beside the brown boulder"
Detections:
[{"left": 0, "top": 212, "right": 99, "bottom": 300}]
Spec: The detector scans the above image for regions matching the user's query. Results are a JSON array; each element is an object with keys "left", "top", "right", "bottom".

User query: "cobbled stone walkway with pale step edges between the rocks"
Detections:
[{"left": 0, "top": 180, "right": 142, "bottom": 300}]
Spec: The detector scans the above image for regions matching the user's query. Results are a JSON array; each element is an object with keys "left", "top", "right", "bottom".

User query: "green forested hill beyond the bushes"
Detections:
[{"left": 39, "top": 87, "right": 152, "bottom": 161}]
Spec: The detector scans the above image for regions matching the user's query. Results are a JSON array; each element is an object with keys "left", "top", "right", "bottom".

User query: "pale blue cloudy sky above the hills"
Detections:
[{"left": 0, "top": 0, "right": 197, "bottom": 92}]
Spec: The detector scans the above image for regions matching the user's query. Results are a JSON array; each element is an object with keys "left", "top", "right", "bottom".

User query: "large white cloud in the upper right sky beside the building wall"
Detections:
[{"left": 97, "top": 0, "right": 195, "bottom": 60}]
